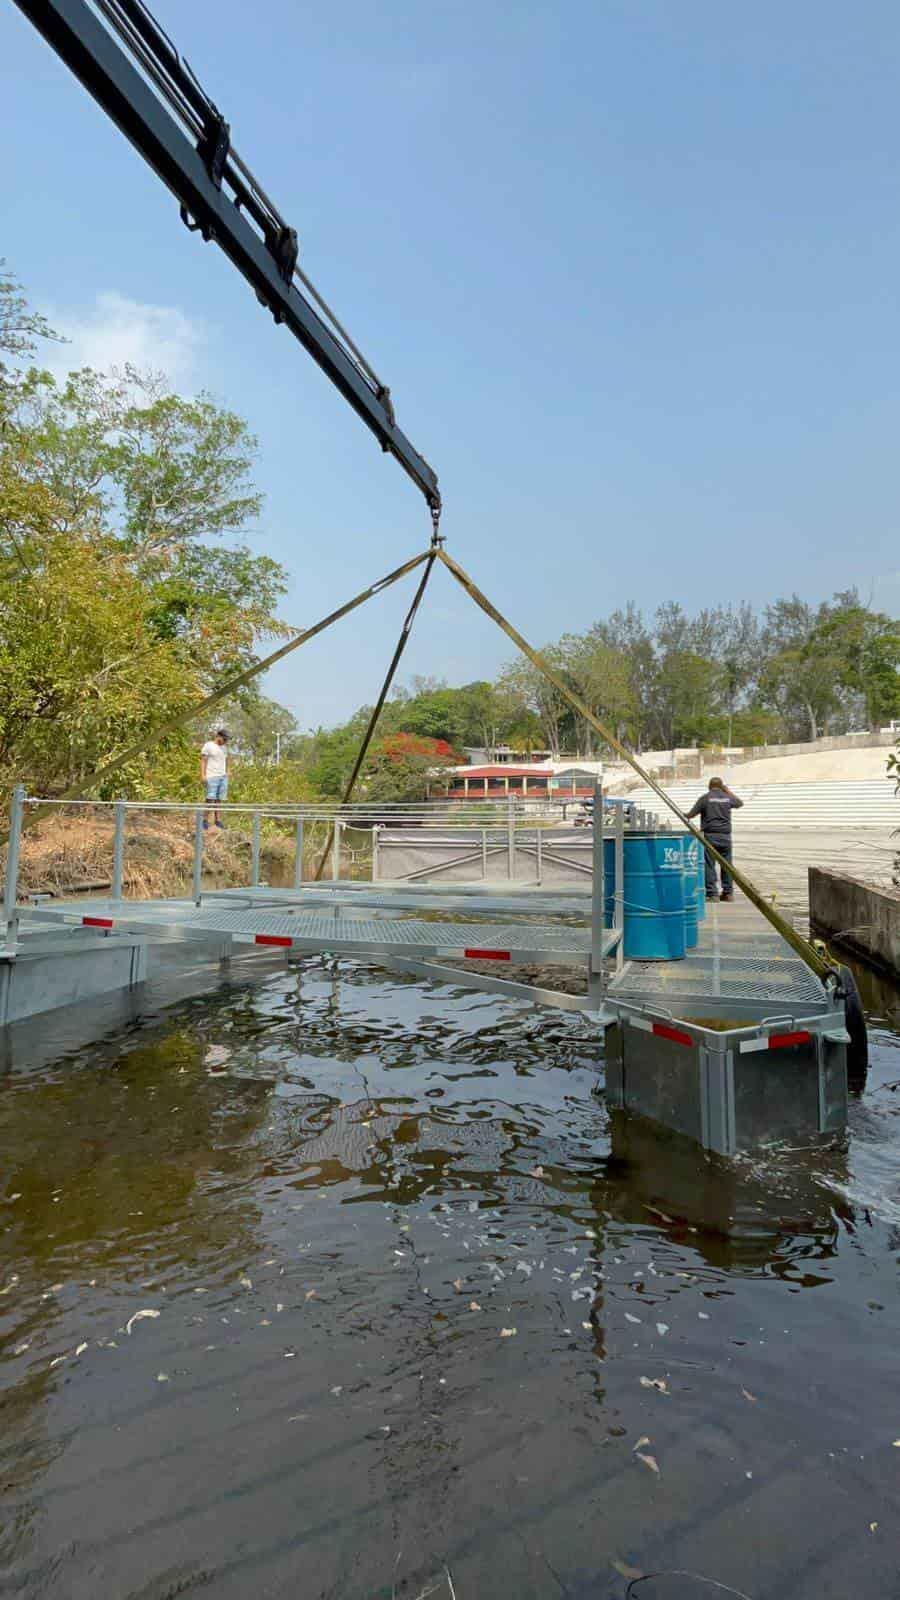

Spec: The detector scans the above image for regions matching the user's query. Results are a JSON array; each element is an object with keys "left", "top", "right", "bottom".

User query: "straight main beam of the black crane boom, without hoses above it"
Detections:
[{"left": 16, "top": 0, "right": 440, "bottom": 507}]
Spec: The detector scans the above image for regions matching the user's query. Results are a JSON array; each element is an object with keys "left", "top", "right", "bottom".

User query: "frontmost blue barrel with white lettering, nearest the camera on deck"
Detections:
[{"left": 625, "top": 832, "right": 687, "bottom": 962}]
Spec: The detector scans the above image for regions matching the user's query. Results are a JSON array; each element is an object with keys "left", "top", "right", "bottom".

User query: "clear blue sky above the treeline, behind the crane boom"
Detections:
[{"left": 0, "top": 0, "right": 900, "bottom": 726}]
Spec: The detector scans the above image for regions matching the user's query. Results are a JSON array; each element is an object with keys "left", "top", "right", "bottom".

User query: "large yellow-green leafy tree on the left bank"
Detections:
[{"left": 0, "top": 277, "right": 285, "bottom": 794}]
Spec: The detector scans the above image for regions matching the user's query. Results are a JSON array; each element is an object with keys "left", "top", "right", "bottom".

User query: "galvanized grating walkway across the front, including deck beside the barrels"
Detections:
[{"left": 14, "top": 882, "right": 831, "bottom": 1021}]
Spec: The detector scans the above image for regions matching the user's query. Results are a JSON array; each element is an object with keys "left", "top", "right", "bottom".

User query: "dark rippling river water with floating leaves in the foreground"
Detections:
[{"left": 0, "top": 960, "right": 900, "bottom": 1600}]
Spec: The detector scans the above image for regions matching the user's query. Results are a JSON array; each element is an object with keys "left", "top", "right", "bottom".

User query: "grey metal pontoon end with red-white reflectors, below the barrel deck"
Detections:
[{"left": 604, "top": 1002, "right": 850, "bottom": 1155}]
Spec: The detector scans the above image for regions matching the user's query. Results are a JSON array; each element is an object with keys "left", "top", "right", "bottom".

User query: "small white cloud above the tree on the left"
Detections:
[{"left": 42, "top": 291, "right": 203, "bottom": 394}]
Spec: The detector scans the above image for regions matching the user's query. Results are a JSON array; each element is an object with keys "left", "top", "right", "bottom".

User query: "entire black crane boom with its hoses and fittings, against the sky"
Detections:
[{"left": 16, "top": 0, "right": 440, "bottom": 514}]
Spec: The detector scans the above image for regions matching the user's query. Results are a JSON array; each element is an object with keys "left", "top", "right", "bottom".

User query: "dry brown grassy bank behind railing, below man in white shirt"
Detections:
[{"left": 8, "top": 811, "right": 293, "bottom": 899}]
